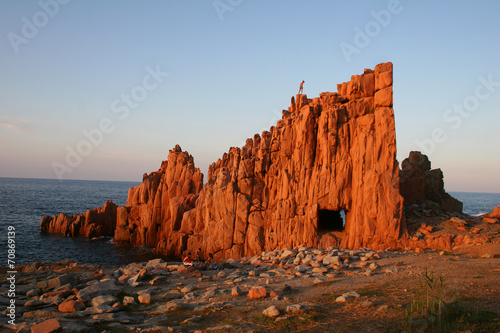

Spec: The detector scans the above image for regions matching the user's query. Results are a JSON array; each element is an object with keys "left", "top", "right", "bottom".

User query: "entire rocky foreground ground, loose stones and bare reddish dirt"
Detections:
[{"left": 0, "top": 211, "right": 500, "bottom": 332}]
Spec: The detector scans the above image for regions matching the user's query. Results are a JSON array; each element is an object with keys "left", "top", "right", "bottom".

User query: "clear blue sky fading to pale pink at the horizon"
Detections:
[{"left": 0, "top": 0, "right": 500, "bottom": 192}]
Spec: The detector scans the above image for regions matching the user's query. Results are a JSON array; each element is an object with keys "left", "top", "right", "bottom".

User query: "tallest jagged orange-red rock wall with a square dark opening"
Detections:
[{"left": 182, "top": 63, "right": 404, "bottom": 258}]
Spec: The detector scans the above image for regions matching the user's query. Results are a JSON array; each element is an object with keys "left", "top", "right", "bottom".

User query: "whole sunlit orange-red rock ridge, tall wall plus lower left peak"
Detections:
[{"left": 42, "top": 63, "right": 406, "bottom": 259}]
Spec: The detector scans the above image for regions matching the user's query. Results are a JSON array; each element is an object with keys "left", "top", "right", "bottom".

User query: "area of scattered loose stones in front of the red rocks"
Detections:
[{"left": 3, "top": 247, "right": 381, "bottom": 332}]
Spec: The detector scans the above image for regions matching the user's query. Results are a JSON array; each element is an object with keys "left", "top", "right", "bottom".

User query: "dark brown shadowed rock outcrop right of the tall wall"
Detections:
[{"left": 399, "top": 151, "right": 463, "bottom": 213}]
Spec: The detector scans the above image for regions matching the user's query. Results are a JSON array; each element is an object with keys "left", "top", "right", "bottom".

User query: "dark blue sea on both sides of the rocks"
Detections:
[{"left": 0, "top": 177, "right": 500, "bottom": 267}]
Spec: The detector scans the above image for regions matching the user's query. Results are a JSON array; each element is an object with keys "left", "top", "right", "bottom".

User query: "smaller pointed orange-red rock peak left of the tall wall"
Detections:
[{"left": 115, "top": 145, "right": 203, "bottom": 255}]
